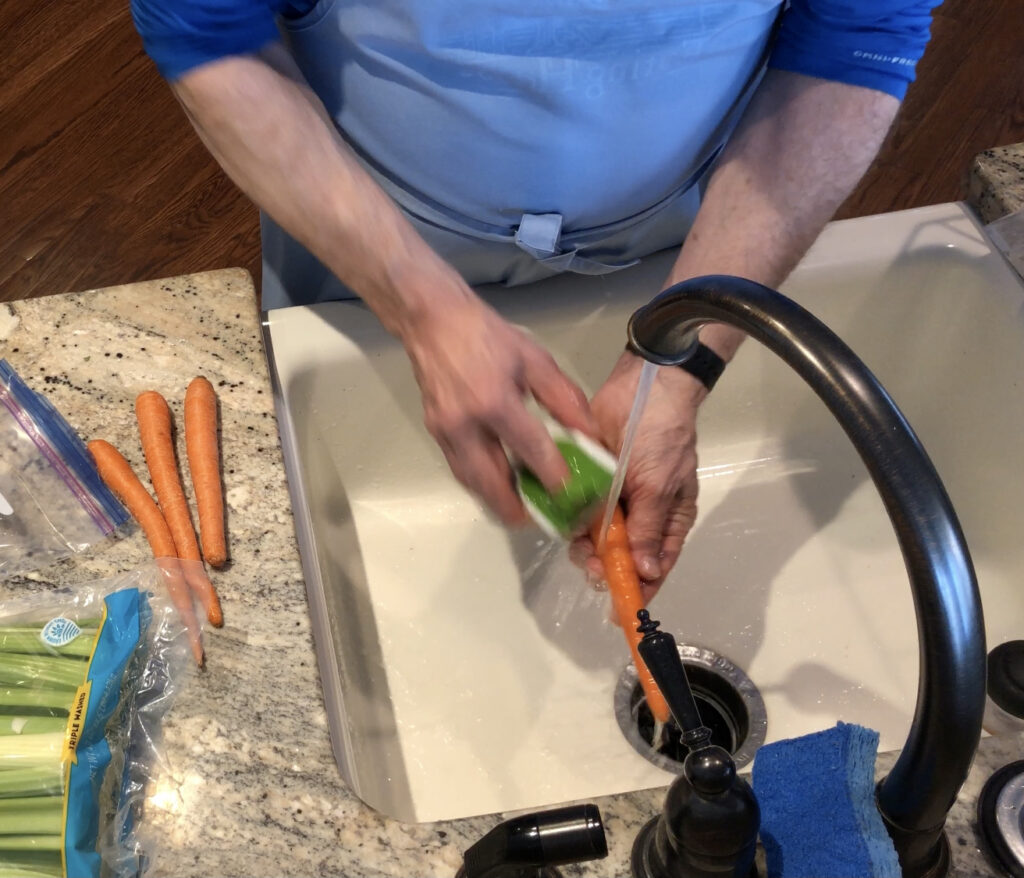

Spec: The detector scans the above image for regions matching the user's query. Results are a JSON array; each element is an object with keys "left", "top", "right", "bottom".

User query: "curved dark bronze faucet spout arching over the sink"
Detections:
[{"left": 629, "top": 276, "right": 985, "bottom": 876}]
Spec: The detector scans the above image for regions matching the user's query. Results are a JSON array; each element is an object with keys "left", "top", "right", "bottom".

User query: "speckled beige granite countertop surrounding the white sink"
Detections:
[{"left": 0, "top": 153, "right": 1024, "bottom": 878}]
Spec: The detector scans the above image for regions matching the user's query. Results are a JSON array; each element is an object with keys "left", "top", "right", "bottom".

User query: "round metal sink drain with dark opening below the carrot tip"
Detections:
[{"left": 614, "top": 643, "right": 768, "bottom": 775}]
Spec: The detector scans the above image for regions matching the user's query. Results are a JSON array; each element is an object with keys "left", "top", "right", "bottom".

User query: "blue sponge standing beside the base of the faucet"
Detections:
[{"left": 754, "top": 722, "right": 901, "bottom": 878}]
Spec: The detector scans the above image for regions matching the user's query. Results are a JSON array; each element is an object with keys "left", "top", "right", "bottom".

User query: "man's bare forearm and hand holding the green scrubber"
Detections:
[{"left": 174, "top": 58, "right": 597, "bottom": 524}]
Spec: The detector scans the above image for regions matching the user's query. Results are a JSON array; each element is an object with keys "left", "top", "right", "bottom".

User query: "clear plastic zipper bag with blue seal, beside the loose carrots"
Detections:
[{"left": 0, "top": 360, "right": 129, "bottom": 579}]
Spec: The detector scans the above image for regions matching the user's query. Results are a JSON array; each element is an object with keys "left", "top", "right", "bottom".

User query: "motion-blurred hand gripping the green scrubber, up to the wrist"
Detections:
[{"left": 401, "top": 295, "right": 597, "bottom": 525}]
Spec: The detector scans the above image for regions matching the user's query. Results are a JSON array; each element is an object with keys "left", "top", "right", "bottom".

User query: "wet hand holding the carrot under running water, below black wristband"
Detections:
[{"left": 570, "top": 352, "right": 708, "bottom": 600}]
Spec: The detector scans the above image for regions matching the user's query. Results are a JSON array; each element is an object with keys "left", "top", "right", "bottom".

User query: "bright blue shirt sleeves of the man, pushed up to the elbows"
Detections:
[{"left": 131, "top": 0, "right": 940, "bottom": 98}]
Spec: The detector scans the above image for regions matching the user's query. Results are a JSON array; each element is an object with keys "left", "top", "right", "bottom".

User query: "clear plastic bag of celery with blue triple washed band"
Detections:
[{"left": 0, "top": 565, "right": 191, "bottom": 878}]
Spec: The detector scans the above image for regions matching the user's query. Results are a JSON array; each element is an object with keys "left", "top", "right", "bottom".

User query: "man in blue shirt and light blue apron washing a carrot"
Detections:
[{"left": 132, "top": 0, "right": 937, "bottom": 596}]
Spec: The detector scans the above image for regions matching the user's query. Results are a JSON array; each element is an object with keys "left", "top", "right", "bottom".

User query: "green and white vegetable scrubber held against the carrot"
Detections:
[{"left": 516, "top": 424, "right": 616, "bottom": 540}]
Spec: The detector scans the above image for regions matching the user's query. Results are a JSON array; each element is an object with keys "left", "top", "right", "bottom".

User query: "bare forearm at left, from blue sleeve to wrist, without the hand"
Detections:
[{"left": 173, "top": 56, "right": 471, "bottom": 336}]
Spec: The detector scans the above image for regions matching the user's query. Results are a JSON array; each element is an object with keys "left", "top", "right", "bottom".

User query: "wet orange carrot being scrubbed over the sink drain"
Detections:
[{"left": 591, "top": 506, "right": 669, "bottom": 722}]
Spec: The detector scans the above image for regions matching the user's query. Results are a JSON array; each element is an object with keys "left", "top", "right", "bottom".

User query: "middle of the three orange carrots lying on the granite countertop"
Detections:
[{"left": 135, "top": 390, "right": 224, "bottom": 628}]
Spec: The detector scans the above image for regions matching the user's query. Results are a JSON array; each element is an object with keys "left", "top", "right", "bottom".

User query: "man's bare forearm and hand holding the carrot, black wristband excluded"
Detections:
[{"left": 571, "top": 70, "right": 899, "bottom": 597}]
